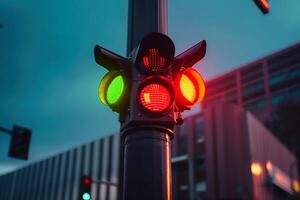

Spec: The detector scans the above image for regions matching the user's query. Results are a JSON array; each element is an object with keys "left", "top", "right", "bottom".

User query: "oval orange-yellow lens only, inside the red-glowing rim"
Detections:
[{"left": 180, "top": 74, "right": 196, "bottom": 103}]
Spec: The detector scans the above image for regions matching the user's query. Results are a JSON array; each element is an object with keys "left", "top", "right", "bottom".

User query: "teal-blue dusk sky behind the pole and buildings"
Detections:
[{"left": 0, "top": 0, "right": 300, "bottom": 174}]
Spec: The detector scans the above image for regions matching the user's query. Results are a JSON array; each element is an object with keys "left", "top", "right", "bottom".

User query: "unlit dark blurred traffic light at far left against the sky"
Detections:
[{"left": 8, "top": 126, "right": 31, "bottom": 160}]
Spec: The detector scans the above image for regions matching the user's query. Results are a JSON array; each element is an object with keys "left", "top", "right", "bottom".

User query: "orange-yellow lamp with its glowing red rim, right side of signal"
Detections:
[{"left": 175, "top": 68, "right": 205, "bottom": 109}]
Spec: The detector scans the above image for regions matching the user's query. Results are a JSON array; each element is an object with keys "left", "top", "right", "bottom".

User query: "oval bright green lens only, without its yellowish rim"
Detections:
[{"left": 106, "top": 75, "right": 124, "bottom": 104}]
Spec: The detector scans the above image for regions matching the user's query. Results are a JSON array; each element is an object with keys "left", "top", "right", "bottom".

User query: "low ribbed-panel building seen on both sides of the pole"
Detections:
[{"left": 0, "top": 104, "right": 299, "bottom": 200}]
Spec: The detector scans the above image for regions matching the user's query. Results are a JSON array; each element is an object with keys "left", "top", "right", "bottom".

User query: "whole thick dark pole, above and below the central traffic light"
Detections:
[{"left": 118, "top": 0, "right": 173, "bottom": 200}]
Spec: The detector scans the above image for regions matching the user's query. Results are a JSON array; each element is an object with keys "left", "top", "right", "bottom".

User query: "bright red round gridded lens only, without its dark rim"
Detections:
[{"left": 140, "top": 83, "right": 171, "bottom": 112}]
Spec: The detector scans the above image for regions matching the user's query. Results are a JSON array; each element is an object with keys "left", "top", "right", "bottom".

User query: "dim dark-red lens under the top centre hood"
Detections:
[{"left": 143, "top": 48, "right": 168, "bottom": 72}]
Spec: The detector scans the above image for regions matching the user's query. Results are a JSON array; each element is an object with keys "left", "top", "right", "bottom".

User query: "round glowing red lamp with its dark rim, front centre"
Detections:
[{"left": 138, "top": 76, "right": 174, "bottom": 113}]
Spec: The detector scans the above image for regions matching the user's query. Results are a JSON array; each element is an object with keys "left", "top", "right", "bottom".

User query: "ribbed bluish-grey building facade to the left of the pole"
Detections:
[{"left": 0, "top": 134, "right": 119, "bottom": 200}]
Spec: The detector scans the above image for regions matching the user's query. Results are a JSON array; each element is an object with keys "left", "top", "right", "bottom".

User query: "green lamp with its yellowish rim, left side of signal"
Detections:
[{"left": 98, "top": 71, "right": 125, "bottom": 105}]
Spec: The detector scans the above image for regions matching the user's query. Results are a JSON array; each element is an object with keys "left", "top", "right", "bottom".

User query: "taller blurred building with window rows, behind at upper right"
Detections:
[{"left": 203, "top": 43, "right": 300, "bottom": 122}]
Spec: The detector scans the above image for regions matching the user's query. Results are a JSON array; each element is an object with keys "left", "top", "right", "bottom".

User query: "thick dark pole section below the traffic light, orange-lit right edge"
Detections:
[{"left": 123, "top": 127, "right": 173, "bottom": 200}]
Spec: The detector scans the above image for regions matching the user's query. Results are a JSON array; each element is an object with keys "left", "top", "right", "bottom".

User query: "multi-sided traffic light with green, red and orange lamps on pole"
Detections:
[{"left": 94, "top": 33, "right": 206, "bottom": 129}]
